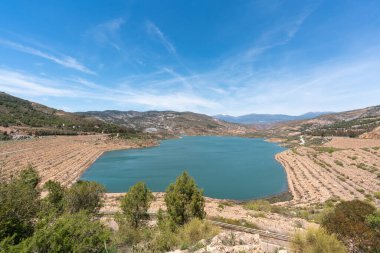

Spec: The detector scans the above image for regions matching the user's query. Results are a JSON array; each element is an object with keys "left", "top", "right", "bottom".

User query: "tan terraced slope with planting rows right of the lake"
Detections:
[{"left": 276, "top": 138, "right": 380, "bottom": 206}]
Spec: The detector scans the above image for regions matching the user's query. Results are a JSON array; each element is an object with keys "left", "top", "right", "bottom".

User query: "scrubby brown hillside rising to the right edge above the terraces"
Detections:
[{"left": 269, "top": 106, "right": 380, "bottom": 138}]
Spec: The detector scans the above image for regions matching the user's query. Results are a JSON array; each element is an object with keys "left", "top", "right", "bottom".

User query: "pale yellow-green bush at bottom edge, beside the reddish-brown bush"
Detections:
[{"left": 291, "top": 228, "right": 347, "bottom": 253}]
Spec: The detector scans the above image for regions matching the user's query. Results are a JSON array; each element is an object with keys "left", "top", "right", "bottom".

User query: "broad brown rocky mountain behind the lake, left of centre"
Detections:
[{"left": 79, "top": 110, "right": 252, "bottom": 135}]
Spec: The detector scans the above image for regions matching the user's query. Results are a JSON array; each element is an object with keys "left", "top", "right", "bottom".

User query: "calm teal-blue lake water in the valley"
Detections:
[{"left": 81, "top": 136, "right": 287, "bottom": 200}]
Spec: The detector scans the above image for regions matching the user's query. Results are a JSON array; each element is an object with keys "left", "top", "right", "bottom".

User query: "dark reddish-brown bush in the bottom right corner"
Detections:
[{"left": 321, "top": 200, "right": 380, "bottom": 252}]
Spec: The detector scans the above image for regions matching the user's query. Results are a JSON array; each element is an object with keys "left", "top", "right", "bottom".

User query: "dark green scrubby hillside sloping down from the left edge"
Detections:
[{"left": 0, "top": 92, "right": 137, "bottom": 135}]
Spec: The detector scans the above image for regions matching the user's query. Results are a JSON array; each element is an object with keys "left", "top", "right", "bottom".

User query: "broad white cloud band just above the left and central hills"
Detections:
[{"left": 0, "top": 68, "right": 219, "bottom": 112}]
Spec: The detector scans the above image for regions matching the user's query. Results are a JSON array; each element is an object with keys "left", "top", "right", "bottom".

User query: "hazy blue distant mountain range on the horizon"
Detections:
[{"left": 214, "top": 112, "right": 331, "bottom": 125}]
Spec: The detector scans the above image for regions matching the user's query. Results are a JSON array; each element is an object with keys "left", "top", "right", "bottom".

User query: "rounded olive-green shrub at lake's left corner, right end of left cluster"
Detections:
[{"left": 64, "top": 181, "right": 105, "bottom": 213}]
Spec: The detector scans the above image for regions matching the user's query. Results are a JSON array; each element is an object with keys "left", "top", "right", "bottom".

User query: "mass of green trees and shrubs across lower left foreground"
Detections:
[{"left": 0, "top": 166, "right": 214, "bottom": 253}]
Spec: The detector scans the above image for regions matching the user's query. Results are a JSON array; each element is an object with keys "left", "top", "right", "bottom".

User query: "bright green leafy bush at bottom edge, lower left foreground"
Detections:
[{"left": 20, "top": 211, "right": 110, "bottom": 253}]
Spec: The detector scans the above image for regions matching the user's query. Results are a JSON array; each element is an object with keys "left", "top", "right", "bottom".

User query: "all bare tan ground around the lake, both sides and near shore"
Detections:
[{"left": 0, "top": 134, "right": 380, "bottom": 234}]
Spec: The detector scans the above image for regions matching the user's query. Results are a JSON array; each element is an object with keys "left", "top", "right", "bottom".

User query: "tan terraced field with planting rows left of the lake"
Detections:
[{"left": 0, "top": 135, "right": 155, "bottom": 186}]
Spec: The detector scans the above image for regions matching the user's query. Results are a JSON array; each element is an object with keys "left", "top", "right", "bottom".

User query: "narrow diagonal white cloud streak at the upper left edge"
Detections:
[{"left": 0, "top": 39, "right": 96, "bottom": 75}]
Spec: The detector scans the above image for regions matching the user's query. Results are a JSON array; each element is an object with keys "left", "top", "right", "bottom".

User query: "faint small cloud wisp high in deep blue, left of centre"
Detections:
[{"left": 87, "top": 17, "right": 125, "bottom": 51}]
